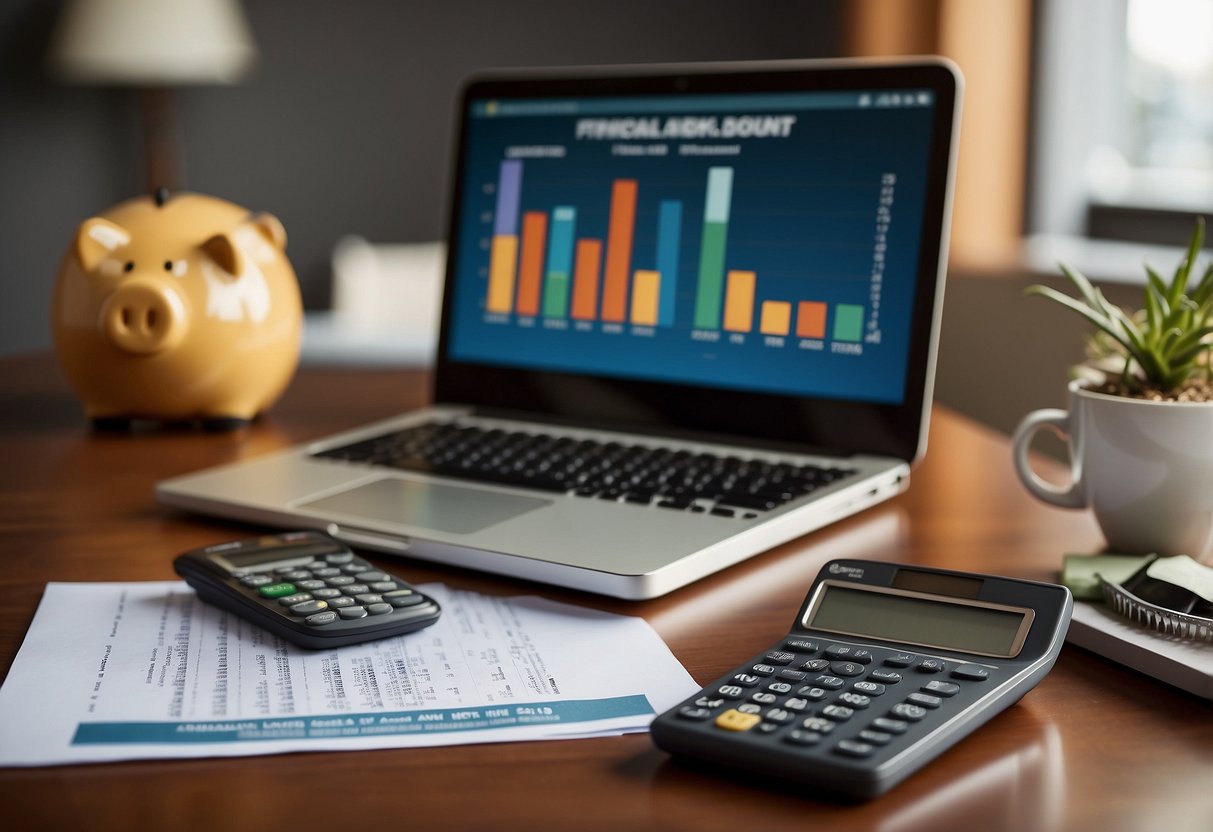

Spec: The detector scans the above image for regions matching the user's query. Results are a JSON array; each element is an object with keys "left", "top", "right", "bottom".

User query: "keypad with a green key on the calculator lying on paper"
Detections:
[{"left": 235, "top": 553, "right": 426, "bottom": 627}]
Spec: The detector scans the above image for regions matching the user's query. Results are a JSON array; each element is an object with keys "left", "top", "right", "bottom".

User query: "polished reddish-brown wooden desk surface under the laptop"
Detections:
[{"left": 0, "top": 357, "right": 1213, "bottom": 832}]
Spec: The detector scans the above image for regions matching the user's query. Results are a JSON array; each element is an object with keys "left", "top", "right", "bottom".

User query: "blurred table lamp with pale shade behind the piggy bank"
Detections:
[{"left": 50, "top": 0, "right": 256, "bottom": 192}]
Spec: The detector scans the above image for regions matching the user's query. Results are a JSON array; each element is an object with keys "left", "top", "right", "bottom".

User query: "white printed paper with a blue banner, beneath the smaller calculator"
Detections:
[{"left": 0, "top": 581, "right": 699, "bottom": 765}]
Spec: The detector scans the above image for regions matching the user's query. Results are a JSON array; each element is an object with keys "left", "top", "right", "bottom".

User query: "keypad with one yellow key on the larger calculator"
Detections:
[{"left": 678, "top": 639, "right": 990, "bottom": 758}]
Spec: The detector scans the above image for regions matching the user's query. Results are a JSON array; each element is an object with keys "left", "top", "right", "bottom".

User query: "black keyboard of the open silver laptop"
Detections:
[{"left": 313, "top": 422, "right": 855, "bottom": 518}]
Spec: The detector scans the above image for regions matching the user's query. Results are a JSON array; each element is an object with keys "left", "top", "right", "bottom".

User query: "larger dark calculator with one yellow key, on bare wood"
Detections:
[{"left": 651, "top": 560, "right": 1074, "bottom": 800}]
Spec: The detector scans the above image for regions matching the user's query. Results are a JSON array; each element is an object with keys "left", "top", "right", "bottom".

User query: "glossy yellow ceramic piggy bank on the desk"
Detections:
[{"left": 53, "top": 189, "right": 302, "bottom": 429}]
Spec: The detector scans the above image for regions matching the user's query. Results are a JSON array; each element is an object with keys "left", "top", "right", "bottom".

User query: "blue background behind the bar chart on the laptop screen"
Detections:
[{"left": 448, "top": 91, "right": 934, "bottom": 404}]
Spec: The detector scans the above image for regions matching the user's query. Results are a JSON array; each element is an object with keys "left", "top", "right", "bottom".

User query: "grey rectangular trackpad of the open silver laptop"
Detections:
[{"left": 298, "top": 478, "right": 551, "bottom": 535}]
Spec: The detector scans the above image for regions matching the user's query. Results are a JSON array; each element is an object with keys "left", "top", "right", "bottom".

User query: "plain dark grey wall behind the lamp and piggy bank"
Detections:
[{"left": 0, "top": 0, "right": 844, "bottom": 355}]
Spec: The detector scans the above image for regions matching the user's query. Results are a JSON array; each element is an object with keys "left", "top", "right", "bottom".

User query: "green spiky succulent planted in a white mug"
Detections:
[{"left": 1014, "top": 218, "right": 1213, "bottom": 560}]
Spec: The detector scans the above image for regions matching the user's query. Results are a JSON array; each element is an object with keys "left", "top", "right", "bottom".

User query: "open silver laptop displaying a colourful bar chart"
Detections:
[{"left": 156, "top": 59, "right": 959, "bottom": 599}]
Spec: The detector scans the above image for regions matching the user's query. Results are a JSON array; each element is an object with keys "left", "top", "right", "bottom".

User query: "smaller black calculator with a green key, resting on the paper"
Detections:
[{"left": 172, "top": 531, "right": 442, "bottom": 649}]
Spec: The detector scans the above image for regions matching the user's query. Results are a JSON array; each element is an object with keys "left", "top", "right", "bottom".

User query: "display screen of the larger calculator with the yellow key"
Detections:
[{"left": 804, "top": 581, "right": 1033, "bottom": 659}]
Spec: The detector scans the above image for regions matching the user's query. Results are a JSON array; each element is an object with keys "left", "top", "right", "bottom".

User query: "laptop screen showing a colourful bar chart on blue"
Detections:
[{"left": 442, "top": 61, "right": 953, "bottom": 458}]
